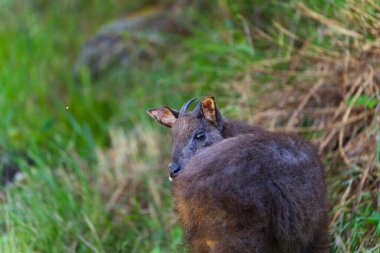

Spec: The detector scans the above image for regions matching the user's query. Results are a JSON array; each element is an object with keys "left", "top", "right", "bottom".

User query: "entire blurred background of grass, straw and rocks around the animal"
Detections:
[{"left": 0, "top": 0, "right": 380, "bottom": 253}]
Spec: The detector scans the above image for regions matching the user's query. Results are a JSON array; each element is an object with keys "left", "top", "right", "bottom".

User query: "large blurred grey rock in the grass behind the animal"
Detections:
[{"left": 74, "top": 3, "right": 187, "bottom": 78}]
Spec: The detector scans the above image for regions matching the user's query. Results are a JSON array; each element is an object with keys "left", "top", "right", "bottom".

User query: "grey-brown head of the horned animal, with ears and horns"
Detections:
[{"left": 147, "top": 96, "right": 223, "bottom": 180}]
